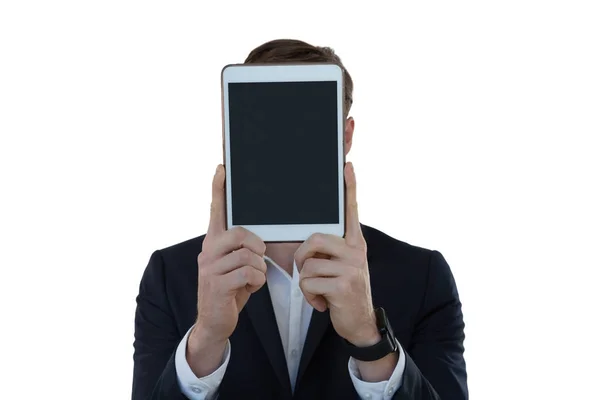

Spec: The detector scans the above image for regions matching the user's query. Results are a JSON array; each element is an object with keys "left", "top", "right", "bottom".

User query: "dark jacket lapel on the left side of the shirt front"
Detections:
[{"left": 244, "top": 285, "right": 292, "bottom": 396}]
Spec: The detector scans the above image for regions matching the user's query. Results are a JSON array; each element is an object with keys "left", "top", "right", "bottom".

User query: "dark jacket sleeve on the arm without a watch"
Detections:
[{"left": 131, "top": 251, "right": 186, "bottom": 400}]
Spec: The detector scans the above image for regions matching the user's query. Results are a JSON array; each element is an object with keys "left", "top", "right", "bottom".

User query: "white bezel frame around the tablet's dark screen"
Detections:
[{"left": 221, "top": 63, "right": 346, "bottom": 242}]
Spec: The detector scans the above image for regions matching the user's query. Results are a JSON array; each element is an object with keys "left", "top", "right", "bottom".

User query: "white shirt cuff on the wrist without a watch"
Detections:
[{"left": 175, "top": 326, "right": 231, "bottom": 400}]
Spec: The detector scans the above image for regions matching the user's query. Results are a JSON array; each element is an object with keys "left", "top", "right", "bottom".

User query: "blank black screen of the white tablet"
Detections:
[{"left": 228, "top": 81, "right": 341, "bottom": 225}]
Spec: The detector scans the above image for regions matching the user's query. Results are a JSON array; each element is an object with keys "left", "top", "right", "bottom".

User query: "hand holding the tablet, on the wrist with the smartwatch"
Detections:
[{"left": 294, "top": 162, "right": 381, "bottom": 347}]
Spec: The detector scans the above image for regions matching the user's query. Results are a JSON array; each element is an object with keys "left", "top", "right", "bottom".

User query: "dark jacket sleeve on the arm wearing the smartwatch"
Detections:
[{"left": 393, "top": 251, "right": 469, "bottom": 400}]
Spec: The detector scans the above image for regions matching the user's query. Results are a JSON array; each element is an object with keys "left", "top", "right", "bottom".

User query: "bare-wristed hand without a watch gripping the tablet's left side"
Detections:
[{"left": 186, "top": 165, "right": 267, "bottom": 376}]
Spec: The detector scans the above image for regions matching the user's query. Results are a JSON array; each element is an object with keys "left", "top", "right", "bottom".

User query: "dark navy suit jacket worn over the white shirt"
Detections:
[{"left": 132, "top": 225, "right": 468, "bottom": 400}]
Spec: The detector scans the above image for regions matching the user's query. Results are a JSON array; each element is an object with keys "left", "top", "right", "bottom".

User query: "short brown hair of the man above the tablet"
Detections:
[{"left": 244, "top": 39, "right": 354, "bottom": 117}]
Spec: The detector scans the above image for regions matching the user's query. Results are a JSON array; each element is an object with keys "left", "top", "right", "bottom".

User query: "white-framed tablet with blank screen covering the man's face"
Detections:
[{"left": 221, "top": 64, "right": 345, "bottom": 242}]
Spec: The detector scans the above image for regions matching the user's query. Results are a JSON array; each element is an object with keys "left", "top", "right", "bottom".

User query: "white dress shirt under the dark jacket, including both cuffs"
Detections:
[{"left": 175, "top": 257, "right": 406, "bottom": 400}]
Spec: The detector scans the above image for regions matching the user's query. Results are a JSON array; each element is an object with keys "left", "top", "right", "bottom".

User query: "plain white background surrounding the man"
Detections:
[{"left": 0, "top": 0, "right": 600, "bottom": 400}]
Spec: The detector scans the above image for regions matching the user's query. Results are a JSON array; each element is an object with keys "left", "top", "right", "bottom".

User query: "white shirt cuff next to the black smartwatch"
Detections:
[{"left": 348, "top": 340, "right": 406, "bottom": 400}]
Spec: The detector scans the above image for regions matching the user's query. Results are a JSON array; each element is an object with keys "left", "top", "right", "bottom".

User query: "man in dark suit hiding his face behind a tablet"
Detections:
[{"left": 133, "top": 40, "right": 468, "bottom": 400}]
